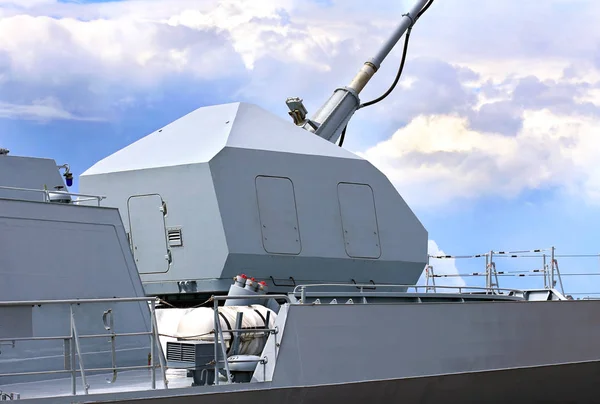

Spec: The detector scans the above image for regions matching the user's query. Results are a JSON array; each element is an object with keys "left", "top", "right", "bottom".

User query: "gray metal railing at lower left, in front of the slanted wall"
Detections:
[{"left": 0, "top": 297, "right": 168, "bottom": 395}]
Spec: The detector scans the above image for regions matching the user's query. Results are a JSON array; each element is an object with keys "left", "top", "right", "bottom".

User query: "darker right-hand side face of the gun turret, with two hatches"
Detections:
[{"left": 210, "top": 147, "right": 427, "bottom": 283}]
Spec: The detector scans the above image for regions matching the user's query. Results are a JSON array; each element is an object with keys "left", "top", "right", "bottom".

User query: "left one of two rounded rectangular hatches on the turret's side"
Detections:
[{"left": 256, "top": 175, "right": 302, "bottom": 254}]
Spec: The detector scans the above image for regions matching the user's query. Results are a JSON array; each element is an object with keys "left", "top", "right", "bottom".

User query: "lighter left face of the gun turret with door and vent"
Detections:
[{"left": 80, "top": 164, "right": 227, "bottom": 288}]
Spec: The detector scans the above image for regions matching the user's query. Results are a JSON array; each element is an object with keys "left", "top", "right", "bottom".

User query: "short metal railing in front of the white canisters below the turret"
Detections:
[{"left": 209, "top": 295, "right": 291, "bottom": 384}]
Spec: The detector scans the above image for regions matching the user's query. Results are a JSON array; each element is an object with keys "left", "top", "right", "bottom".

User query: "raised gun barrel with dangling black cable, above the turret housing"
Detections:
[{"left": 286, "top": 0, "right": 433, "bottom": 143}]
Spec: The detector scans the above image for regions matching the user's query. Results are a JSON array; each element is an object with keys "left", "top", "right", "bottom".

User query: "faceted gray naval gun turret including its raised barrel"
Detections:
[{"left": 80, "top": 1, "right": 428, "bottom": 302}]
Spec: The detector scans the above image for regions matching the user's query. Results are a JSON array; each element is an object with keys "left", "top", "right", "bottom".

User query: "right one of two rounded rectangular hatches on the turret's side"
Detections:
[{"left": 338, "top": 182, "right": 381, "bottom": 258}]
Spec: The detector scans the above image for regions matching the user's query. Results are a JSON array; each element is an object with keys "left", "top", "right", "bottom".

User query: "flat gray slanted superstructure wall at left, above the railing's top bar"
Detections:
[{"left": 0, "top": 199, "right": 143, "bottom": 300}]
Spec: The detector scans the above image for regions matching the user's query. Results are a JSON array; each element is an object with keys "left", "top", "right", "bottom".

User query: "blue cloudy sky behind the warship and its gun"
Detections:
[{"left": 0, "top": 0, "right": 600, "bottom": 294}]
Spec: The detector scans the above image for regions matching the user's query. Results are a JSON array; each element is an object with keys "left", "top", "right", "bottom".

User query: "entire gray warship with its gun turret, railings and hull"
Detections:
[{"left": 0, "top": 0, "right": 600, "bottom": 404}]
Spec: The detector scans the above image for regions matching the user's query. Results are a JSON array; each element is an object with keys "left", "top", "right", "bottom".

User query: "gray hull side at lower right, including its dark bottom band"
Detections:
[{"left": 9, "top": 301, "right": 600, "bottom": 404}]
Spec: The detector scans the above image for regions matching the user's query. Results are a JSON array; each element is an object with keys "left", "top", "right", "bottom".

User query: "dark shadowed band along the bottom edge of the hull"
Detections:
[{"left": 76, "top": 362, "right": 600, "bottom": 404}]
